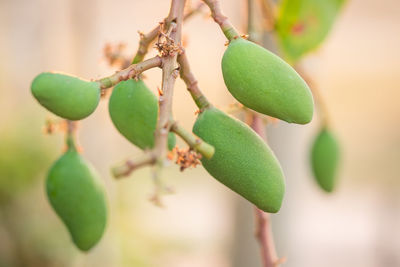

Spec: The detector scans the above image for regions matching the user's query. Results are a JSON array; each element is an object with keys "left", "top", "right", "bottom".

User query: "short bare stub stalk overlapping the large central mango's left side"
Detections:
[{"left": 171, "top": 122, "right": 215, "bottom": 159}]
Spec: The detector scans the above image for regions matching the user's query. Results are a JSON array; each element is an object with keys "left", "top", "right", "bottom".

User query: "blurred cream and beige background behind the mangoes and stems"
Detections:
[{"left": 0, "top": 0, "right": 400, "bottom": 267}]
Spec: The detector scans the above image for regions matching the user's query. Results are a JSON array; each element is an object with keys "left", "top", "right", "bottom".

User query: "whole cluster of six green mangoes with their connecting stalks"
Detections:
[{"left": 31, "top": 1, "right": 337, "bottom": 253}]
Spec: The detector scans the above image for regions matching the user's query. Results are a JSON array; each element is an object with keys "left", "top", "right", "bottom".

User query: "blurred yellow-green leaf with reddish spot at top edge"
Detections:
[{"left": 276, "top": 0, "right": 345, "bottom": 62}]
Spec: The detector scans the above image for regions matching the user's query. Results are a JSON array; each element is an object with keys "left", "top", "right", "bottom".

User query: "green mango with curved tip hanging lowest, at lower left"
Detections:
[{"left": 47, "top": 148, "right": 107, "bottom": 251}]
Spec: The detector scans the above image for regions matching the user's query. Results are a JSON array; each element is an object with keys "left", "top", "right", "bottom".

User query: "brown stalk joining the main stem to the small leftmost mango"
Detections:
[{"left": 97, "top": 56, "right": 163, "bottom": 89}]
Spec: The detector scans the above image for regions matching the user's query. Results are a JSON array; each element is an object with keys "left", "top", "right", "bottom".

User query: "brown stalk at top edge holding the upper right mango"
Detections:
[{"left": 203, "top": 0, "right": 239, "bottom": 41}]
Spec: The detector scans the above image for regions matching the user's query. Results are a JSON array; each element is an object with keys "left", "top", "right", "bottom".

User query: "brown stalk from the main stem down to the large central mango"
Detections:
[{"left": 178, "top": 51, "right": 211, "bottom": 110}]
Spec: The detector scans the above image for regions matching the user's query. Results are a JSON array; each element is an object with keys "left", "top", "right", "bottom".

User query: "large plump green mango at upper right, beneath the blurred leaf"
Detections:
[{"left": 222, "top": 38, "right": 314, "bottom": 124}]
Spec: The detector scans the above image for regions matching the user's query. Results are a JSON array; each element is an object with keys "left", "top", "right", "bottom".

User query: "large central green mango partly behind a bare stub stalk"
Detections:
[{"left": 193, "top": 108, "right": 285, "bottom": 213}]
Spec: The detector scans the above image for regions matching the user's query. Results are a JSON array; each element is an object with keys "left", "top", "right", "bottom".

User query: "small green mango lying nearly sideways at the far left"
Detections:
[{"left": 31, "top": 72, "right": 100, "bottom": 120}]
